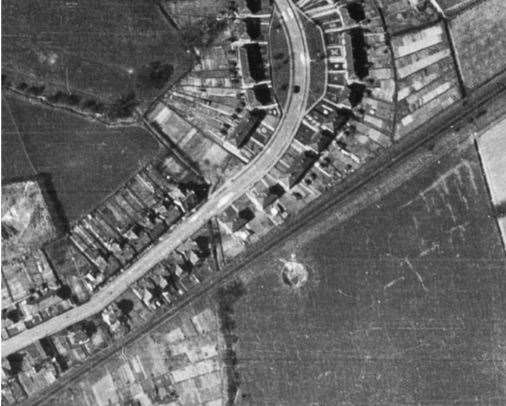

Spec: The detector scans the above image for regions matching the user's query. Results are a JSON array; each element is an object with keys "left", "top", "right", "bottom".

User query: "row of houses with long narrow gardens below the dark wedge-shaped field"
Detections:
[{"left": 65, "top": 159, "right": 202, "bottom": 290}]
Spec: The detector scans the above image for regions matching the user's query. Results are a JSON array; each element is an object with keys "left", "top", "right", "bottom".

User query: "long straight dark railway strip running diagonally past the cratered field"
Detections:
[{"left": 15, "top": 67, "right": 506, "bottom": 406}]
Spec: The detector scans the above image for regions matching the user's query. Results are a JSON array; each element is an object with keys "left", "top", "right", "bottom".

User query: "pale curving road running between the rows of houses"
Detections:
[{"left": 2, "top": 0, "right": 310, "bottom": 357}]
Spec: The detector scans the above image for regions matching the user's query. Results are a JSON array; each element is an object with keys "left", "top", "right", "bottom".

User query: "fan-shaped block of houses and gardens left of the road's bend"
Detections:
[{"left": 148, "top": 2, "right": 279, "bottom": 185}]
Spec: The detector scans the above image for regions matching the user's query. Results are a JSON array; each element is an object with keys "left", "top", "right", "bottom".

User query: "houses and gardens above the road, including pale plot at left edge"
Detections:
[{"left": 2, "top": 156, "right": 207, "bottom": 339}]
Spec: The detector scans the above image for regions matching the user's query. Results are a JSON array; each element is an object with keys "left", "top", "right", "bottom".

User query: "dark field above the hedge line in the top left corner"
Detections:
[{"left": 2, "top": 0, "right": 191, "bottom": 106}]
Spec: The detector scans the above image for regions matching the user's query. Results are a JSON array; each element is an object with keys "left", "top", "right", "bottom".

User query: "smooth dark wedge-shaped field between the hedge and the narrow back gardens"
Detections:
[{"left": 2, "top": 96, "right": 159, "bottom": 220}]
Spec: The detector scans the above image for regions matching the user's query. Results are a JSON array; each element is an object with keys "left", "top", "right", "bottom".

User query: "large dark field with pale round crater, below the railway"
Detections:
[{"left": 233, "top": 146, "right": 506, "bottom": 406}]
